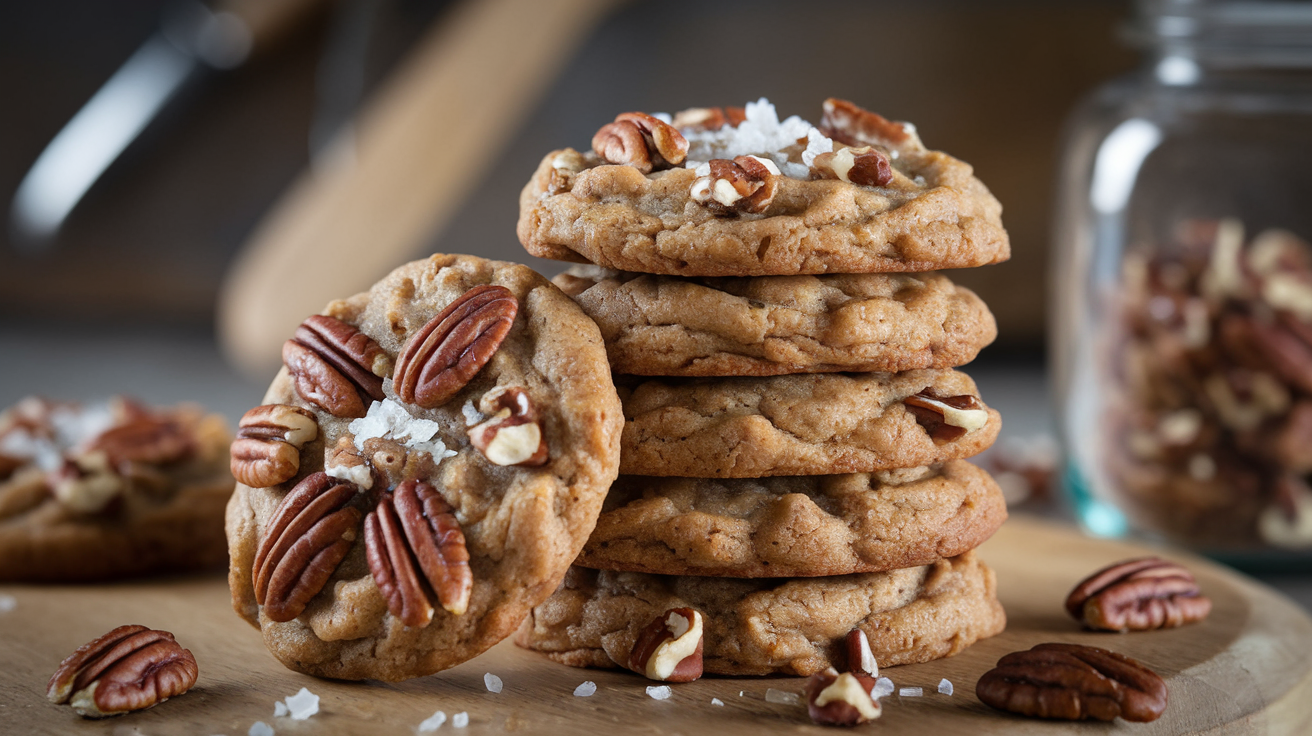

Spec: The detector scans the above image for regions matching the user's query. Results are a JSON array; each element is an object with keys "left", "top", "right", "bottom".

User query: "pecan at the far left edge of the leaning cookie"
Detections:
[{"left": 228, "top": 404, "right": 319, "bottom": 488}]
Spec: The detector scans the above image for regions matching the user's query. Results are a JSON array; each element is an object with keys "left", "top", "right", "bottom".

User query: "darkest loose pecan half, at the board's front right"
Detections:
[{"left": 975, "top": 644, "right": 1166, "bottom": 722}]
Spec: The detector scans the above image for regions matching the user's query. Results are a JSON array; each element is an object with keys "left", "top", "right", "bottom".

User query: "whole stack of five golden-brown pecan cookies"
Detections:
[{"left": 517, "top": 100, "right": 1009, "bottom": 681}]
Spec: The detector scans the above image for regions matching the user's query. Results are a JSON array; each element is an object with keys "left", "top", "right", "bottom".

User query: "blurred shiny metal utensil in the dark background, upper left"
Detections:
[{"left": 9, "top": 0, "right": 319, "bottom": 252}]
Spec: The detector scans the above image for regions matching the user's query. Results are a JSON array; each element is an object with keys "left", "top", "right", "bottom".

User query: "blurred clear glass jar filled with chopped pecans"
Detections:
[{"left": 1050, "top": 0, "right": 1312, "bottom": 567}]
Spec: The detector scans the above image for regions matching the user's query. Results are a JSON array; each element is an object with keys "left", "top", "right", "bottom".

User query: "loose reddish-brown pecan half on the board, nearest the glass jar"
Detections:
[{"left": 1065, "top": 558, "right": 1212, "bottom": 631}]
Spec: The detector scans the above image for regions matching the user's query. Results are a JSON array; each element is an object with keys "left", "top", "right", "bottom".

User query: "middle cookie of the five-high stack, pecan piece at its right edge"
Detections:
[{"left": 619, "top": 370, "right": 1001, "bottom": 478}]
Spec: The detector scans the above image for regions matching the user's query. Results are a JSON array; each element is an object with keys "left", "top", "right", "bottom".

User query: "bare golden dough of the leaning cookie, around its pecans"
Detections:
[{"left": 227, "top": 256, "right": 621, "bottom": 681}]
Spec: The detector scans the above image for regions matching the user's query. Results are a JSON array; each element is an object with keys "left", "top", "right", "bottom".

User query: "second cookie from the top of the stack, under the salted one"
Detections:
[{"left": 555, "top": 266, "right": 997, "bottom": 375}]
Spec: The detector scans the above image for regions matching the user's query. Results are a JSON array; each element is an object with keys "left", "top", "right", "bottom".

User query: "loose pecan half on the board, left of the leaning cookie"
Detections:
[{"left": 46, "top": 626, "right": 198, "bottom": 718}]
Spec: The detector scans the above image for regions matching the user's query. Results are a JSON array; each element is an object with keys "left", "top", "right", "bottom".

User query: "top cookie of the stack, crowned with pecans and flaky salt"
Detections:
[{"left": 517, "top": 100, "right": 1010, "bottom": 276}]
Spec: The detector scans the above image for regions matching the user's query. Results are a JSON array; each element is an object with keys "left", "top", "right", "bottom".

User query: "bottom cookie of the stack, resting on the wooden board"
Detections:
[{"left": 516, "top": 552, "right": 1006, "bottom": 676}]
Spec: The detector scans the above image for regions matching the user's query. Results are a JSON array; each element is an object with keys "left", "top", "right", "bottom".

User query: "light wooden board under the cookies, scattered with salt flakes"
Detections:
[{"left": 0, "top": 518, "right": 1312, "bottom": 736}]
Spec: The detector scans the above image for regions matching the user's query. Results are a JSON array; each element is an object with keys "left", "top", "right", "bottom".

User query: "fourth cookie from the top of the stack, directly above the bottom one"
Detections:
[{"left": 575, "top": 460, "right": 1006, "bottom": 577}]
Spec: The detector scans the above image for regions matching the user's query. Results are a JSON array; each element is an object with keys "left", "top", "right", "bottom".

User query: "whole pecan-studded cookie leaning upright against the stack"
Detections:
[{"left": 227, "top": 256, "right": 622, "bottom": 681}]
